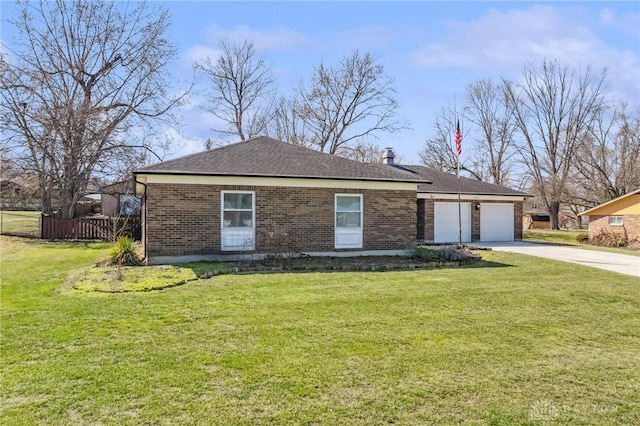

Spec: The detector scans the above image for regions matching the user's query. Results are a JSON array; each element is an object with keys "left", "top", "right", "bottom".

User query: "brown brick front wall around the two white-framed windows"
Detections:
[{"left": 144, "top": 184, "right": 416, "bottom": 257}]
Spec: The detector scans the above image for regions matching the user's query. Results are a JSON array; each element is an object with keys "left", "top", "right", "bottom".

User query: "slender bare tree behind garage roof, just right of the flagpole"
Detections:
[{"left": 464, "top": 80, "right": 516, "bottom": 185}]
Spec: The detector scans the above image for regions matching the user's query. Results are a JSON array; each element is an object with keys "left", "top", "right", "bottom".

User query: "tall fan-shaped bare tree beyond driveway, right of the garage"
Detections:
[{"left": 504, "top": 60, "right": 606, "bottom": 229}]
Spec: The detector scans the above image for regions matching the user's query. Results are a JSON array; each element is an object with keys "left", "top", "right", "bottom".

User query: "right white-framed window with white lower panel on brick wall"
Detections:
[{"left": 335, "top": 194, "right": 363, "bottom": 249}]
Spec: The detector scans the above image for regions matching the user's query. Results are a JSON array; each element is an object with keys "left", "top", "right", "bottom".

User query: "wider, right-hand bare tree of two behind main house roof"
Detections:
[{"left": 294, "top": 50, "right": 407, "bottom": 154}]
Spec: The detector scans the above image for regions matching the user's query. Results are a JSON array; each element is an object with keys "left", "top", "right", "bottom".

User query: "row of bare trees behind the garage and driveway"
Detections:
[{"left": 420, "top": 60, "right": 640, "bottom": 229}]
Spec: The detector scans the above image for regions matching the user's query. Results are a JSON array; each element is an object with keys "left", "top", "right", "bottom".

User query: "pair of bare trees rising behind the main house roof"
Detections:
[{"left": 194, "top": 39, "right": 407, "bottom": 161}]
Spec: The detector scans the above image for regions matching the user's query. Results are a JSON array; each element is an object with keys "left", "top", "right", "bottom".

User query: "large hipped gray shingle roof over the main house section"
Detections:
[{"left": 134, "top": 136, "right": 426, "bottom": 183}]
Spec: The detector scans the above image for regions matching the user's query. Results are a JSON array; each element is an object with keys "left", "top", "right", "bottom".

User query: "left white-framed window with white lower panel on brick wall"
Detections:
[{"left": 220, "top": 191, "right": 256, "bottom": 251}]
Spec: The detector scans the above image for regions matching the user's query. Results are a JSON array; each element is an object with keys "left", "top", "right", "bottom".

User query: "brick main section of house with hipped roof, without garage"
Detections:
[{"left": 134, "top": 137, "right": 427, "bottom": 263}]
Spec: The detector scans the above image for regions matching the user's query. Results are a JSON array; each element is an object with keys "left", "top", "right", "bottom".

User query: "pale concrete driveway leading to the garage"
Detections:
[{"left": 477, "top": 241, "right": 640, "bottom": 277}]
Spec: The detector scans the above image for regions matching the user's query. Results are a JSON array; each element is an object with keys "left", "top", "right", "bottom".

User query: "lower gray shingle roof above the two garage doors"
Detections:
[{"left": 396, "top": 165, "right": 530, "bottom": 197}]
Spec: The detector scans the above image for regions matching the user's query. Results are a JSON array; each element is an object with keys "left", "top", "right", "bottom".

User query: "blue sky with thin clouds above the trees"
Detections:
[{"left": 2, "top": 1, "right": 640, "bottom": 163}]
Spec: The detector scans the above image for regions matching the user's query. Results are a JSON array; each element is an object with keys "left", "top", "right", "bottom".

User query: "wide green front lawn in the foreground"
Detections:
[{"left": 0, "top": 237, "right": 640, "bottom": 425}]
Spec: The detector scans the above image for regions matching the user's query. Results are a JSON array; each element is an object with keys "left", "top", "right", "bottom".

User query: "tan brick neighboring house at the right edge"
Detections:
[{"left": 581, "top": 189, "right": 640, "bottom": 246}]
